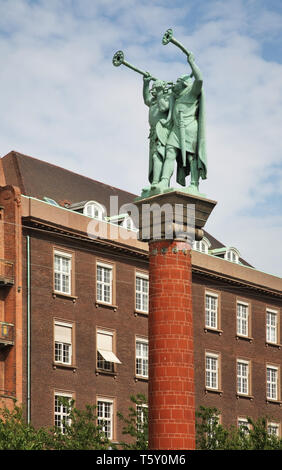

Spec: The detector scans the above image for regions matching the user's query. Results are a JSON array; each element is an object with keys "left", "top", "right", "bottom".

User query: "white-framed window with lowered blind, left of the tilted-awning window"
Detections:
[{"left": 54, "top": 320, "right": 72, "bottom": 365}]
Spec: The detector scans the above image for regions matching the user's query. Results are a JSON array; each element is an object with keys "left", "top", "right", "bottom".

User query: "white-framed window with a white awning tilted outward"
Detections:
[{"left": 97, "top": 329, "right": 121, "bottom": 372}]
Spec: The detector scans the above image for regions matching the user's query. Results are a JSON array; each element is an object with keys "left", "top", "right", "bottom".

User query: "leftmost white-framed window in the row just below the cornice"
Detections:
[{"left": 54, "top": 250, "right": 72, "bottom": 295}]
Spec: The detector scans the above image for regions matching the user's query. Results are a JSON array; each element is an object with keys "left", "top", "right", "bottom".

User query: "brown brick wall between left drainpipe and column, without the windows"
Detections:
[{"left": 24, "top": 232, "right": 147, "bottom": 439}]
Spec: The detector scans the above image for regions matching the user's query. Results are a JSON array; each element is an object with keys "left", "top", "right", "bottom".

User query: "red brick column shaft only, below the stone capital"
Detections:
[{"left": 149, "top": 240, "right": 195, "bottom": 450}]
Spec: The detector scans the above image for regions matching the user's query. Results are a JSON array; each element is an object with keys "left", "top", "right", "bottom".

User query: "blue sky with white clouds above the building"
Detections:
[{"left": 0, "top": 0, "right": 282, "bottom": 276}]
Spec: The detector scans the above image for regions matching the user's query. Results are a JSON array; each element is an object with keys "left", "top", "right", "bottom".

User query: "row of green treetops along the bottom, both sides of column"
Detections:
[{"left": 0, "top": 394, "right": 282, "bottom": 450}]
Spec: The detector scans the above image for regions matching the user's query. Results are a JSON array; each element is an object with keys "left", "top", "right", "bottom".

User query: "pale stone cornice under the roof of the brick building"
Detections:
[{"left": 22, "top": 197, "right": 282, "bottom": 298}]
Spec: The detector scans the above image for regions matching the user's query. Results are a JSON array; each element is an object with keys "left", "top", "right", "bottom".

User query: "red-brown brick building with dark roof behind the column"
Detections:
[{"left": 0, "top": 152, "right": 282, "bottom": 441}]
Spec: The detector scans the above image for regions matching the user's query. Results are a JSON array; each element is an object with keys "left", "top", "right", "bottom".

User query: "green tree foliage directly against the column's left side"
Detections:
[{"left": 118, "top": 394, "right": 148, "bottom": 450}]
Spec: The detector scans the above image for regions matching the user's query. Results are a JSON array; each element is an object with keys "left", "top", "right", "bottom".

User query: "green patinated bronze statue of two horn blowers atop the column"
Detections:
[{"left": 113, "top": 29, "right": 207, "bottom": 197}]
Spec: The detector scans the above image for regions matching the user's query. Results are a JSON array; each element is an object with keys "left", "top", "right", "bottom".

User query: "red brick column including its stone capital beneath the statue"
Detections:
[{"left": 135, "top": 191, "right": 216, "bottom": 450}]
